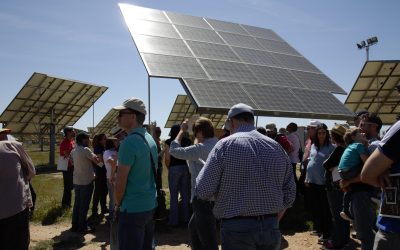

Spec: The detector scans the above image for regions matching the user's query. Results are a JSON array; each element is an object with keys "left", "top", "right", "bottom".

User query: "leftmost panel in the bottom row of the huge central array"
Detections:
[{"left": 183, "top": 79, "right": 255, "bottom": 108}]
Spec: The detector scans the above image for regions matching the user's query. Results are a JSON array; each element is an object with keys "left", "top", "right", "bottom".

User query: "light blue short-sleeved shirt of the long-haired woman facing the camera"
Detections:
[{"left": 305, "top": 144, "right": 335, "bottom": 185}]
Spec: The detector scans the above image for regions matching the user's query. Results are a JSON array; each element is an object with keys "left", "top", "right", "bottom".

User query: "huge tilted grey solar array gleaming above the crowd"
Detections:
[{"left": 120, "top": 4, "right": 350, "bottom": 118}]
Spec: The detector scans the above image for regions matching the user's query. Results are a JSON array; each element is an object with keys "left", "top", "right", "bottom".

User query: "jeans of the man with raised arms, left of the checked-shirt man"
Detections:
[{"left": 189, "top": 196, "right": 218, "bottom": 250}]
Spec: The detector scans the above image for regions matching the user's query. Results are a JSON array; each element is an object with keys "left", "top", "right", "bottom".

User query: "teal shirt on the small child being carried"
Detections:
[{"left": 338, "top": 142, "right": 367, "bottom": 171}]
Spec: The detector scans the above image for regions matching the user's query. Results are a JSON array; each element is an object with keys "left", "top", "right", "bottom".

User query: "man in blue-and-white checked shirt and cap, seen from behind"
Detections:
[{"left": 196, "top": 103, "right": 296, "bottom": 250}]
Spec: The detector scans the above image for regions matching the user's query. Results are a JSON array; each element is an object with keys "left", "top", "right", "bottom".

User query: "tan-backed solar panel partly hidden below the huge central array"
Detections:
[{"left": 165, "top": 95, "right": 227, "bottom": 128}]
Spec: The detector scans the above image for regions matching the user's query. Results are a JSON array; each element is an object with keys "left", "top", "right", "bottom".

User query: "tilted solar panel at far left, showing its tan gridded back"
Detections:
[{"left": 0, "top": 72, "right": 107, "bottom": 135}]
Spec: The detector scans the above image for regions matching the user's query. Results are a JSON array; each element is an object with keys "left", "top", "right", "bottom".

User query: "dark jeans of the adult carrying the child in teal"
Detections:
[{"left": 350, "top": 191, "right": 376, "bottom": 250}]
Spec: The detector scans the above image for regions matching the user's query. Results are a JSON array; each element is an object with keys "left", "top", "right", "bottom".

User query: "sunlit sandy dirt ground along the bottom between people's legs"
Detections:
[{"left": 30, "top": 222, "right": 359, "bottom": 250}]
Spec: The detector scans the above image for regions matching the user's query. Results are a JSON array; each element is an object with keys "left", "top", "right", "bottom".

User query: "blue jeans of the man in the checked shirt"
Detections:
[{"left": 221, "top": 216, "right": 281, "bottom": 250}]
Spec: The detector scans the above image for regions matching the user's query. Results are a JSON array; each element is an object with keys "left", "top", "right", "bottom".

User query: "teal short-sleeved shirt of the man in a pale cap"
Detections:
[{"left": 118, "top": 128, "right": 157, "bottom": 213}]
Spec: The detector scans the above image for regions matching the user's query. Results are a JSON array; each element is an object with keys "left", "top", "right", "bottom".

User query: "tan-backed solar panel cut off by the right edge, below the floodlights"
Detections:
[{"left": 345, "top": 60, "right": 400, "bottom": 125}]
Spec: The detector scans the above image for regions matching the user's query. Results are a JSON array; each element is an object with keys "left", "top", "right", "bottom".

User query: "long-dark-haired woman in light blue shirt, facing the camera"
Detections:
[{"left": 305, "top": 123, "right": 334, "bottom": 243}]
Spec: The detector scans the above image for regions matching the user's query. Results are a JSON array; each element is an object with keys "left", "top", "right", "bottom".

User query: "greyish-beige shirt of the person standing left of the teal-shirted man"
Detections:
[{"left": 71, "top": 145, "right": 96, "bottom": 185}]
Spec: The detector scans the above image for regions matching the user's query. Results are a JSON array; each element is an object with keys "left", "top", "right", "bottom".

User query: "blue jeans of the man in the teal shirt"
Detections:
[{"left": 118, "top": 210, "right": 155, "bottom": 250}]
